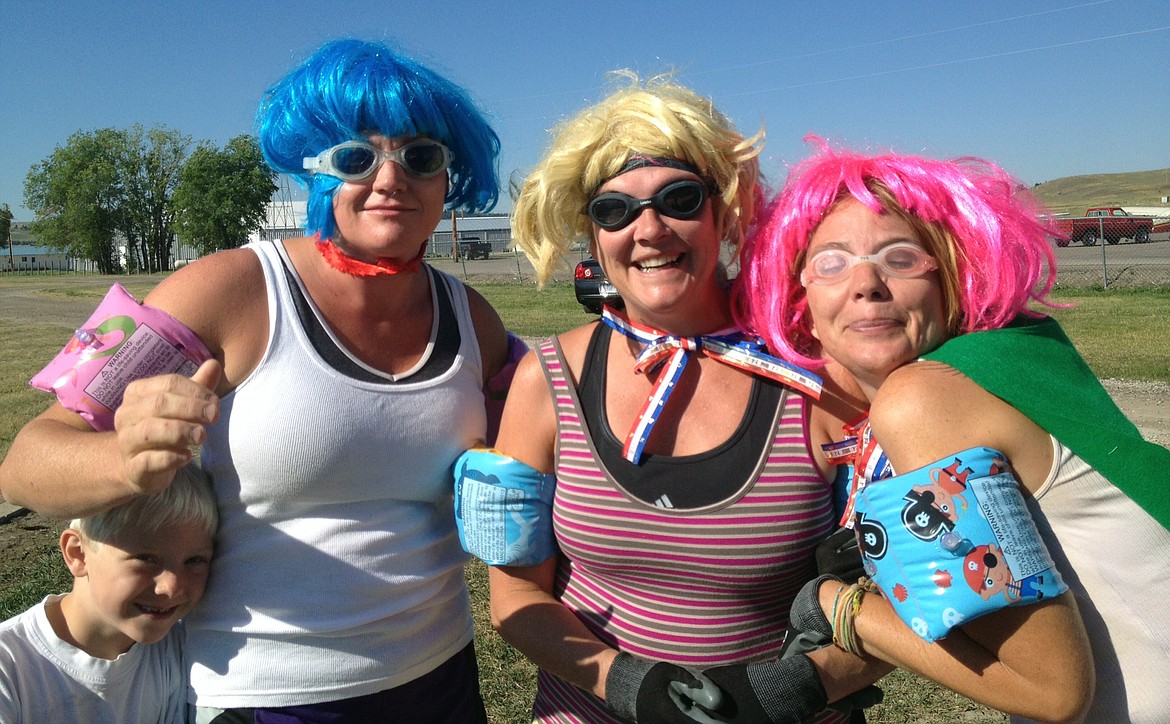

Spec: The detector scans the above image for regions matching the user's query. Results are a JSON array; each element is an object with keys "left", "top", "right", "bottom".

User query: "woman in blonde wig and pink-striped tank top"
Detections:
[{"left": 477, "top": 80, "right": 886, "bottom": 722}]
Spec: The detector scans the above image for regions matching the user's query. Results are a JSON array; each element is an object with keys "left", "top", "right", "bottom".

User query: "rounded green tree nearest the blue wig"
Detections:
[{"left": 171, "top": 135, "right": 276, "bottom": 254}]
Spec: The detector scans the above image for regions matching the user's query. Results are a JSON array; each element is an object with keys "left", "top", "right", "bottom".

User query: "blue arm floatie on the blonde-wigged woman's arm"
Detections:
[{"left": 455, "top": 448, "right": 557, "bottom": 566}]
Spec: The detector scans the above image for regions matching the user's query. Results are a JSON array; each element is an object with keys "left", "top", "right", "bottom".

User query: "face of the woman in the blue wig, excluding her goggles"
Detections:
[{"left": 333, "top": 133, "right": 447, "bottom": 262}]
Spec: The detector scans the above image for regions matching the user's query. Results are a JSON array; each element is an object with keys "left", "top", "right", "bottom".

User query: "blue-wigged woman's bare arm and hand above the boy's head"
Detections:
[{"left": 0, "top": 250, "right": 267, "bottom": 518}]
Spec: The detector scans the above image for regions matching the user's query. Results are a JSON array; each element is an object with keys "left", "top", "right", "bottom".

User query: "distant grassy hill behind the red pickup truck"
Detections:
[{"left": 1032, "top": 168, "right": 1170, "bottom": 215}]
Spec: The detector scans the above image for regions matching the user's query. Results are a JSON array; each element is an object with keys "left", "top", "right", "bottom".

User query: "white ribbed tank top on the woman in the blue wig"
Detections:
[{"left": 187, "top": 242, "right": 486, "bottom": 709}]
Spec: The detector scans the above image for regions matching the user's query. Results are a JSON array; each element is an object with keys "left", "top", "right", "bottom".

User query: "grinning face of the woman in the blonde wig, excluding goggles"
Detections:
[{"left": 593, "top": 166, "right": 730, "bottom": 335}]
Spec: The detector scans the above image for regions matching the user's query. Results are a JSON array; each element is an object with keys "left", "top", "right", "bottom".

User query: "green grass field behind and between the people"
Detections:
[{"left": 0, "top": 277, "right": 1170, "bottom": 723}]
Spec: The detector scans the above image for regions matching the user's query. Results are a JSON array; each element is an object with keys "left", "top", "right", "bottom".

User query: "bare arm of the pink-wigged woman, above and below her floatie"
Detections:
[{"left": 851, "top": 363, "right": 1094, "bottom": 720}]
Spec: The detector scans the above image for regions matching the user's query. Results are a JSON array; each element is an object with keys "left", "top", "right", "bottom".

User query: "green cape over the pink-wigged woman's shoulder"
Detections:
[{"left": 923, "top": 317, "right": 1170, "bottom": 530}]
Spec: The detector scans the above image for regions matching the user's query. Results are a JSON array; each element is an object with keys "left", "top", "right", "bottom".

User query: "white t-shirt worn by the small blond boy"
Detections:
[{"left": 0, "top": 594, "right": 187, "bottom": 724}]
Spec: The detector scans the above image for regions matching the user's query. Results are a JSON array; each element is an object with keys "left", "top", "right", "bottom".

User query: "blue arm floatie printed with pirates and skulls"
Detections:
[{"left": 854, "top": 448, "right": 1068, "bottom": 641}]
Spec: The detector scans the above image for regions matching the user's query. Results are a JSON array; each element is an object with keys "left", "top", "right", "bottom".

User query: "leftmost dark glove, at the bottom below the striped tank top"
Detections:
[{"left": 605, "top": 653, "right": 723, "bottom": 724}]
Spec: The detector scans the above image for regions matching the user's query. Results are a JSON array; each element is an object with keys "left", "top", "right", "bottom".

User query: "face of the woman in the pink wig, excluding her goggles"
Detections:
[{"left": 805, "top": 198, "right": 948, "bottom": 399}]
